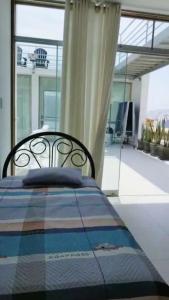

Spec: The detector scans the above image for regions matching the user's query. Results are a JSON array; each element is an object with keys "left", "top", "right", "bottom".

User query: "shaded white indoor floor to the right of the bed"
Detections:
[{"left": 109, "top": 196, "right": 169, "bottom": 284}]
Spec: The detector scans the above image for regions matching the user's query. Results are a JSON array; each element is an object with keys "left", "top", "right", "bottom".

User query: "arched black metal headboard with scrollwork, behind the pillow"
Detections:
[{"left": 2, "top": 131, "right": 95, "bottom": 178}]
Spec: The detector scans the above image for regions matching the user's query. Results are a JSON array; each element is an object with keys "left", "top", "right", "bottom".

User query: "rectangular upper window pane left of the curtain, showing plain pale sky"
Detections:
[{"left": 16, "top": 5, "right": 64, "bottom": 40}]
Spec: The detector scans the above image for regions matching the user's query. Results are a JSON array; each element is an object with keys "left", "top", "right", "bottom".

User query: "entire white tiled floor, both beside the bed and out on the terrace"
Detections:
[{"left": 103, "top": 145, "right": 169, "bottom": 284}]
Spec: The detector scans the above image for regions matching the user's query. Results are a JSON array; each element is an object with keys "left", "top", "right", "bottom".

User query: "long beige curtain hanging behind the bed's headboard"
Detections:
[{"left": 61, "top": 0, "right": 120, "bottom": 184}]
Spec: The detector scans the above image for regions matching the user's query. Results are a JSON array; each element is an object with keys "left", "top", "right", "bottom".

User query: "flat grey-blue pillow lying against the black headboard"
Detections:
[{"left": 23, "top": 168, "right": 83, "bottom": 186}]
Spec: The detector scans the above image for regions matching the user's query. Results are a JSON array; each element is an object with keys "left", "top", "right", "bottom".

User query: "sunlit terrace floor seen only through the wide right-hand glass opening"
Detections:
[{"left": 119, "top": 146, "right": 169, "bottom": 195}]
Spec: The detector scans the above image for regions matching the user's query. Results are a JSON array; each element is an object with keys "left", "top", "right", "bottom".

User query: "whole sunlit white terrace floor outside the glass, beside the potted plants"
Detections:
[{"left": 102, "top": 144, "right": 169, "bottom": 195}]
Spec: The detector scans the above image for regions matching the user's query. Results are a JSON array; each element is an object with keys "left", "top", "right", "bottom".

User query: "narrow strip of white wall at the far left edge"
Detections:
[{"left": 0, "top": 0, "right": 11, "bottom": 174}]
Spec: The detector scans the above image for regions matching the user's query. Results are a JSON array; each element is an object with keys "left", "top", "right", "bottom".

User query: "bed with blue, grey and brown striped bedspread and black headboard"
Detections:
[{"left": 0, "top": 132, "right": 169, "bottom": 300}]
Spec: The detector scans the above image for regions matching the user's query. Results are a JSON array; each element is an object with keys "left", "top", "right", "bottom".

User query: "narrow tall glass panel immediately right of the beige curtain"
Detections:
[{"left": 102, "top": 53, "right": 131, "bottom": 195}]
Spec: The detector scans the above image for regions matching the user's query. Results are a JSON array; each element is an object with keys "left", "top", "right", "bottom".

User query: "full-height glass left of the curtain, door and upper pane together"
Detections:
[{"left": 15, "top": 4, "right": 64, "bottom": 143}]
